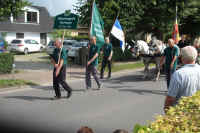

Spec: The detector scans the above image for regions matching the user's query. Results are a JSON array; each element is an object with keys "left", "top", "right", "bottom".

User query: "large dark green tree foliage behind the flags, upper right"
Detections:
[{"left": 75, "top": 0, "right": 200, "bottom": 40}]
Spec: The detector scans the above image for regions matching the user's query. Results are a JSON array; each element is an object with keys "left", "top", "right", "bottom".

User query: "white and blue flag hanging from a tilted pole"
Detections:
[{"left": 111, "top": 19, "right": 125, "bottom": 51}]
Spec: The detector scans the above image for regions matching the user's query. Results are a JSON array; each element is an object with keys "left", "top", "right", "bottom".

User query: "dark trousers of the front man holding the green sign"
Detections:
[{"left": 53, "top": 65, "right": 72, "bottom": 97}]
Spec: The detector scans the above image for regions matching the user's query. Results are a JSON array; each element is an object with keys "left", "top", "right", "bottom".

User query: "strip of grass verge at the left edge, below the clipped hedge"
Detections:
[{"left": 0, "top": 79, "right": 37, "bottom": 89}]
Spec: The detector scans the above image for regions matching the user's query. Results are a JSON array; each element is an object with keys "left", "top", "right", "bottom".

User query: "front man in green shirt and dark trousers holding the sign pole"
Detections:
[{"left": 51, "top": 39, "right": 72, "bottom": 99}]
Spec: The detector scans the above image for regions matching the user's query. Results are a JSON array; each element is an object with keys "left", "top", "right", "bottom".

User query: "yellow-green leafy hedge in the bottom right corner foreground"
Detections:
[{"left": 133, "top": 91, "right": 200, "bottom": 133}]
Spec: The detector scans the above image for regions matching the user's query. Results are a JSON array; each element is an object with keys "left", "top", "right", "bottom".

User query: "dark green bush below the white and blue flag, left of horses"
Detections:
[{"left": 113, "top": 47, "right": 132, "bottom": 61}]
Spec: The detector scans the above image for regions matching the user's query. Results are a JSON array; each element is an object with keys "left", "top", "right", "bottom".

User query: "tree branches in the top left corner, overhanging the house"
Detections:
[{"left": 0, "top": 0, "right": 30, "bottom": 20}]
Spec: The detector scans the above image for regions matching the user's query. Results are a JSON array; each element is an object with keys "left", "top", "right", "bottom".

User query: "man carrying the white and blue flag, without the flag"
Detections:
[{"left": 100, "top": 37, "right": 113, "bottom": 79}]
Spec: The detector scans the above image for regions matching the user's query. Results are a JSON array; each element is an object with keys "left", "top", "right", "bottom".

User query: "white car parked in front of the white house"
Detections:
[{"left": 8, "top": 39, "right": 45, "bottom": 54}]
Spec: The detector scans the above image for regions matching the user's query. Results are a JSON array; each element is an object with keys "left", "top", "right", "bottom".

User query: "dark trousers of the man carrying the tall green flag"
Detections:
[{"left": 85, "top": 65, "right": 100, "bottom": 87}]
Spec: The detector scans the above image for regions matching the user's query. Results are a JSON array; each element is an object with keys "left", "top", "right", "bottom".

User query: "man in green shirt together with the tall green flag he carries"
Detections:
[{"left": 85, "top": 1, "right": 104, "bottom": 90}]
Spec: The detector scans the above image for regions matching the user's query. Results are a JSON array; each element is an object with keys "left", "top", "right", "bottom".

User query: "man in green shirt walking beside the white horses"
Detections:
[{"left": 160, "top": 39, "right": 179, "bottom": 88}]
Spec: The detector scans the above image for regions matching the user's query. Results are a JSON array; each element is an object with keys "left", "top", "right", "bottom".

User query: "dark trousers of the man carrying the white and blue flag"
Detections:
[{"left": 101, "top": 57, "right": 111, "bottom": 78}]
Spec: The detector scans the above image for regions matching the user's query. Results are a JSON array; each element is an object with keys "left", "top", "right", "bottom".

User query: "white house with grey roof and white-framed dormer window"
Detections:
[{"left": 0, "top": 6, "right": 53, "bottom": 45}]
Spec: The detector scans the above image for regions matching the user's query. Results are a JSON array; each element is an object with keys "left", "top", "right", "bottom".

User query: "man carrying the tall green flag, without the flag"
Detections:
[{"left": 85, "top": 36, "right": 101, "bottom": 90}]
